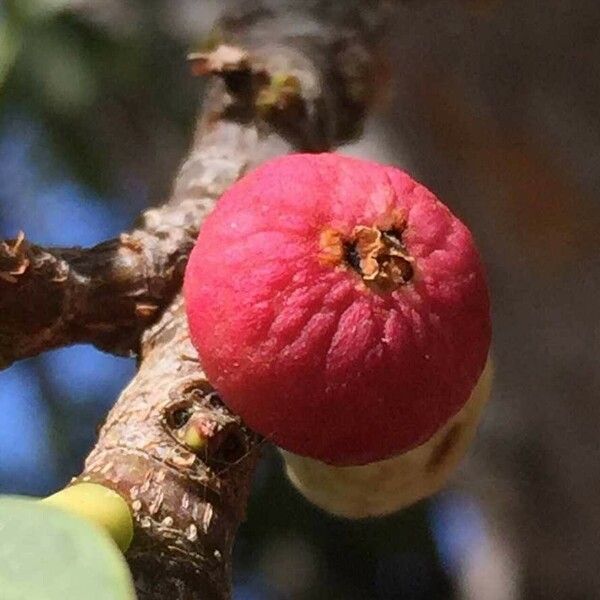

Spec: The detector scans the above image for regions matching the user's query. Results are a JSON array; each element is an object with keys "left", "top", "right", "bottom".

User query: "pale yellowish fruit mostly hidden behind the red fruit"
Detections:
[{"left": 282, "top": 360, "right": 492, "bottom": 519}]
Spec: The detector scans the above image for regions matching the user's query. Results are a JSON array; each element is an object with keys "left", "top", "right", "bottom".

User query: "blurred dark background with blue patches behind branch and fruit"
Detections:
[{"left": 0, "top": 0, "right": 600, "bottom": 600}]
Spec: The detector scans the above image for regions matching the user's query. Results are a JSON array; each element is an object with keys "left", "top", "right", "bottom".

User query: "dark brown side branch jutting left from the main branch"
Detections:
[{"left": 0, "top": 209, "right": 203, "bottom": 369}]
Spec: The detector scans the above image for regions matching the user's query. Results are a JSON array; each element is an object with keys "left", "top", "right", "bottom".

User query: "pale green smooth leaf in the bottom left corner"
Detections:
[{"left": 0, "top": 497, "right": 136, "bottom": 600}]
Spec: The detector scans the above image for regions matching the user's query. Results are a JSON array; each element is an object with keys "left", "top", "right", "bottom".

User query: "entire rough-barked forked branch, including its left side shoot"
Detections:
[{"left": 7, "top": 1, "right": 396, "bottom": 600}]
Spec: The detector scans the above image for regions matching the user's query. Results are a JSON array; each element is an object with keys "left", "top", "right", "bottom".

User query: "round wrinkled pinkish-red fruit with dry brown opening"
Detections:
[{"left": 184, "top": 154, "right": 491, "bottom": 465}]
